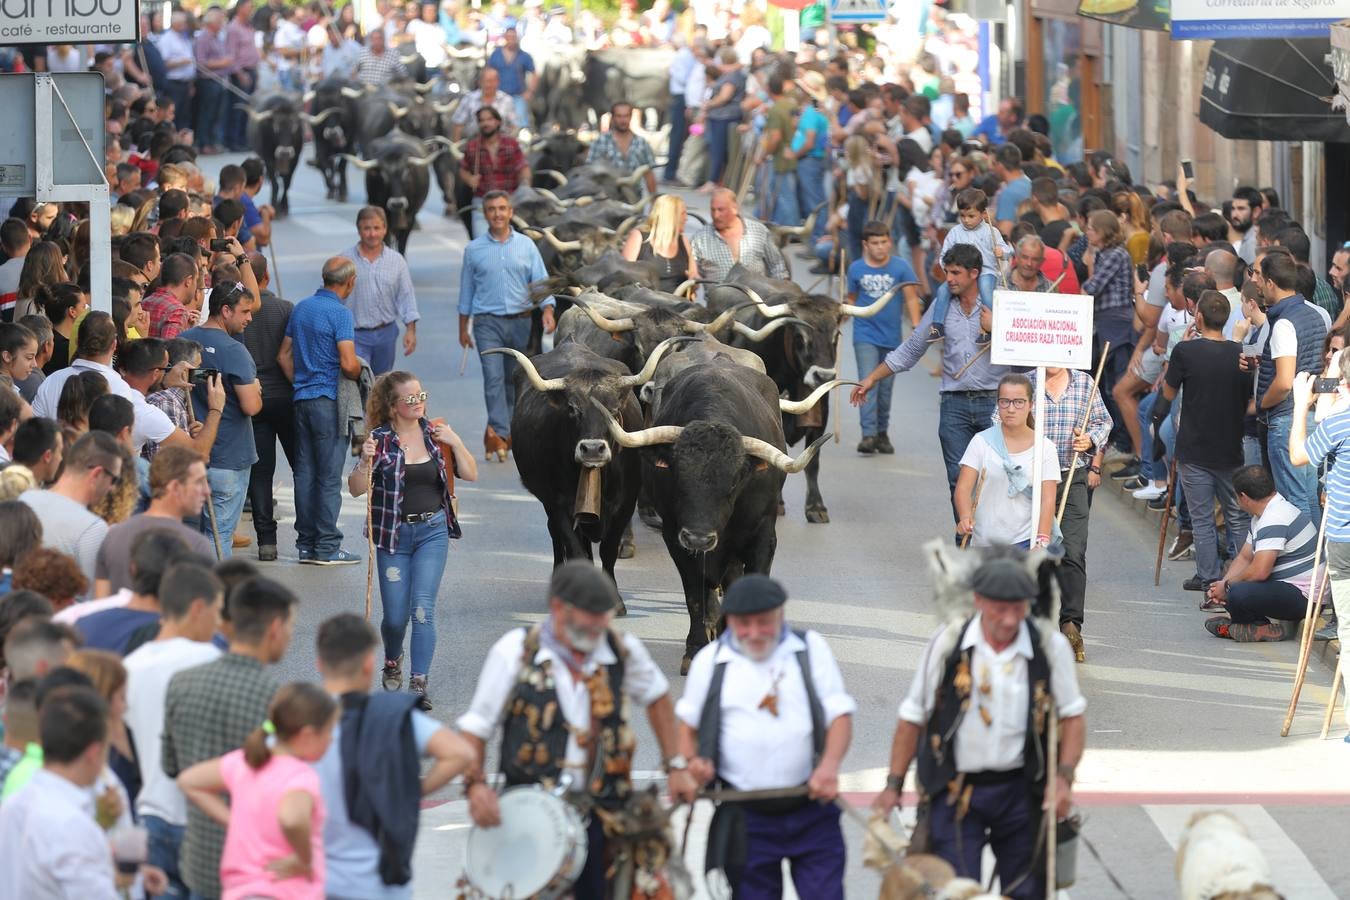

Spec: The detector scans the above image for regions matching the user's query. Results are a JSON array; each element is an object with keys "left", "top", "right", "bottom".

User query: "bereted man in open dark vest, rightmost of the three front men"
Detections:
[{"left": 875, "top": 551, "right": 1087, "bottom": 900}]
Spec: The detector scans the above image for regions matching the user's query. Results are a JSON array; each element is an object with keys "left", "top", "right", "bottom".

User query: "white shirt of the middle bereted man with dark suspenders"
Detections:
[{"left": 675, "top": 630, "right": 857, "bottom": 791}]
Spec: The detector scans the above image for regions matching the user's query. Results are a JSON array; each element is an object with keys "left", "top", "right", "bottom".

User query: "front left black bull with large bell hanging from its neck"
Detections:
[{"left": 485, "top": 334, "right": 685, "bottom": 601}]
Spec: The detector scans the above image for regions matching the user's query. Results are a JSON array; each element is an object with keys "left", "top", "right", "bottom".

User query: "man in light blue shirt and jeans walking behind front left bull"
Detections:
[{"left": 459, "top": 190, "right": 555, "bottom": 460}]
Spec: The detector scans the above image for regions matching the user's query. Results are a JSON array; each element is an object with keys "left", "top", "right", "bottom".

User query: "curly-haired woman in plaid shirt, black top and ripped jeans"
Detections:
[{"left": 347, "top": 371, "right": 478, "bottom": 711}]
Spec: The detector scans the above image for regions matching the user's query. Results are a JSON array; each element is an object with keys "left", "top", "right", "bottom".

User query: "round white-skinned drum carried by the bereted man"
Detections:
[{"left": 464, "top": 785, "right": 587, "bottom": 900}]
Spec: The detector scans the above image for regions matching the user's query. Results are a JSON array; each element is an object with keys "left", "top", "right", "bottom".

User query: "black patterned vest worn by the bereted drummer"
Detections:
[{"left": 501, "top": 626, "right": 637, "bottom": 810}]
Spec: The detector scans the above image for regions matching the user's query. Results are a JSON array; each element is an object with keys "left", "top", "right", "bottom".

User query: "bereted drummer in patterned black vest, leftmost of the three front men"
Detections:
[{"left": 458, "top": 560, "right": 694, "bottom": 900}]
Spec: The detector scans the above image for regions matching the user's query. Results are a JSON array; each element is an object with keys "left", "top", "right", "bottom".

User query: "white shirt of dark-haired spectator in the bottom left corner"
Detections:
[{"left": 0, "top": 769, "right": 119, "bottom": 900}]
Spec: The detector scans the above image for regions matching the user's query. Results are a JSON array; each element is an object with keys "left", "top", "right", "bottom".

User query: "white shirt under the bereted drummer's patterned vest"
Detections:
[{"left": 456, "top": 629, "right": 670, "bottom": 784}]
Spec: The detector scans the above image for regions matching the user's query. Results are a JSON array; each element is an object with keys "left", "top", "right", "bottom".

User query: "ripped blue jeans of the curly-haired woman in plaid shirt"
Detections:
[{"left": 375, "top": 513, "right": 450, "bottom": 675}]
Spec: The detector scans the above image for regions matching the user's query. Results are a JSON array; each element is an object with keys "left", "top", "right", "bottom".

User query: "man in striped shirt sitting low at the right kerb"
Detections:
[{"left": 1204, "top": 466, "right": 1318, "bottom": 641}]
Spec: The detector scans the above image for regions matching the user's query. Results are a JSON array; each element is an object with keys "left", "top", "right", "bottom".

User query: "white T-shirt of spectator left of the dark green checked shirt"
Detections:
[{"left": 123, "top": 637, "right": 220, "bottom": 824}]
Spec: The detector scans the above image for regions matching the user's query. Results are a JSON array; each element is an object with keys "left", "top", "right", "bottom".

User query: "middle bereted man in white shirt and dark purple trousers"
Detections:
[{"left": 675, "top": 575, "right": 857, "bottom": 900}]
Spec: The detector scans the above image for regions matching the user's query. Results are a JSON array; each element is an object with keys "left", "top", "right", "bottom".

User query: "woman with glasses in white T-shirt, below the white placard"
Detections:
[{"left": 954, "top": 375, "right": 1060, "bottom": 548}]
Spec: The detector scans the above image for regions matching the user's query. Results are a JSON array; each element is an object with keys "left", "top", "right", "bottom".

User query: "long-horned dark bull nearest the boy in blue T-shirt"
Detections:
[{"left": 707, "top": 266, "right": 905, "bottom": 524}]
